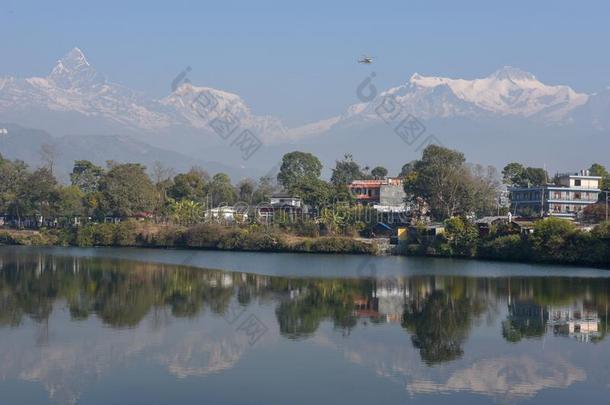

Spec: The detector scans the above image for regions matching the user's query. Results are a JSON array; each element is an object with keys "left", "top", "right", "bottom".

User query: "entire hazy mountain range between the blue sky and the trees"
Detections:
[{"left": 0, "top": 48, "right": 610, "bottom": 177}]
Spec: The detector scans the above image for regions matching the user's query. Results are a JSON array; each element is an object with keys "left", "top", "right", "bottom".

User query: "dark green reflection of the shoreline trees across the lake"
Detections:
[{"left": 0, "top": 251, "right": 610, "bottom": 350}]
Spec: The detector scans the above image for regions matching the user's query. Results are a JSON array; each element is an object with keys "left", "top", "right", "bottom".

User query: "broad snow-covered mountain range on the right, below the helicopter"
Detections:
[{"left": 290, "top": 66, "right": 589, "bottom": 137}]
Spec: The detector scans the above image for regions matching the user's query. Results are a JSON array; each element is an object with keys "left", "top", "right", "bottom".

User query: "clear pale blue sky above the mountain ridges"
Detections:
[{"left": 0, "top": 0, "right": 610, "bottom": 125}]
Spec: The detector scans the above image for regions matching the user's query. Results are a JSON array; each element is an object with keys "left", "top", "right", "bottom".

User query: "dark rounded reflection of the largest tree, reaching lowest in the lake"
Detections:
[{"left": 402, "top": 291, "right": 477, "bottom": 364}]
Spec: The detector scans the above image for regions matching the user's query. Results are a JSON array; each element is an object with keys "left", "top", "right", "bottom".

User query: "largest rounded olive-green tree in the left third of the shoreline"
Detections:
[{"left": 99, "top": 163, "right": 157, "bottom": 217}]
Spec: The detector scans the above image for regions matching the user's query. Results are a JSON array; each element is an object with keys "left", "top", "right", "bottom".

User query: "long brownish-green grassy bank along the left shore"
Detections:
[{"left": 0, "top": 222, "right": 378, "bottom": 255}]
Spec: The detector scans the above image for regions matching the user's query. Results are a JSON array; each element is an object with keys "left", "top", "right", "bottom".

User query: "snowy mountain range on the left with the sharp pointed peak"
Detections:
[{"left": 0, "top": 48, "right": 284, "bottom": 139}]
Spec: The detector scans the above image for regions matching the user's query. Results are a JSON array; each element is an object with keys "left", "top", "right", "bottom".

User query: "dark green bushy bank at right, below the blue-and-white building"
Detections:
[{"left": 400, "top": 218, "right": 610, "bottom": 268}]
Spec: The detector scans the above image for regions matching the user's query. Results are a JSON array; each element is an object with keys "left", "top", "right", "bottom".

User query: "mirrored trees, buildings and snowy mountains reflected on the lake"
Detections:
[{"left": 0, "top": 250, "right": 610, "bottom": 403}]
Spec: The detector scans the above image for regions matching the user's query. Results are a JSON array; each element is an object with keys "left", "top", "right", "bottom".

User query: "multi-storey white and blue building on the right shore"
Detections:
[{"left": 509, "top": 170, "right": 601, "bottom": 219}]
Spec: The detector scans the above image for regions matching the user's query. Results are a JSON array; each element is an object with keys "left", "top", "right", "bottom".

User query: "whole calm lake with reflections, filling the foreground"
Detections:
[{"left": 0, "top": 247, "right": 610, "bottom": 404}]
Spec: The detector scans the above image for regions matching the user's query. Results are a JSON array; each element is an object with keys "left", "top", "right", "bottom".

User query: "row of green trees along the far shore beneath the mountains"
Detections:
[{"left": 0, "top": 145, "right": 610, "bottom": 224}]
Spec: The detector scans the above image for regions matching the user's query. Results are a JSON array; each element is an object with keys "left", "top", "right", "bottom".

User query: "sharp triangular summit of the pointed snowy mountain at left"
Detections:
[{"left": 48, "top": 47, "right": 105, "bottom": 89}]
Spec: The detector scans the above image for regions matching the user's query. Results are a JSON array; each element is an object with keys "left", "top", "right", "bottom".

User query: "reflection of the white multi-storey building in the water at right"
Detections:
[{"left": 548, "top": 303, "right": 601, "bottom": 342}]
